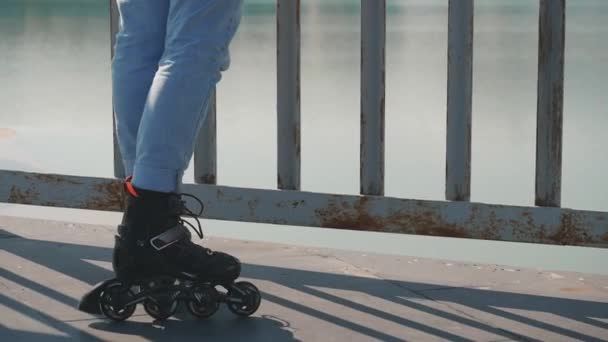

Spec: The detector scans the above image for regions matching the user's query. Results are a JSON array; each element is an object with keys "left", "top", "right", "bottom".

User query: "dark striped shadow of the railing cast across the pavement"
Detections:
[{"left": 0, "top": 230, "right": 608, "bottom": 341}]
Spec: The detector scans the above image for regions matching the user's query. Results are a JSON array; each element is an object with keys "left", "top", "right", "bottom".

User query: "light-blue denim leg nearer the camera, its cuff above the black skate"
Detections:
[{"left": 132, "top": 0, "right": 242, "bottom": 192}]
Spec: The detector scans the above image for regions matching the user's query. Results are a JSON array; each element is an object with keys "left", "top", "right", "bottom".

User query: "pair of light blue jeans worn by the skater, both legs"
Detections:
[{"left": 112, "top": 0, "right": 242, "bottom": 192}]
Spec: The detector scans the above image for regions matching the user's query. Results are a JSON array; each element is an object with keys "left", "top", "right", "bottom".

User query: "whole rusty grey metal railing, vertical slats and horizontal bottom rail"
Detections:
[{"left": 0, "top": 0, "right": 608, "bottom": 248}]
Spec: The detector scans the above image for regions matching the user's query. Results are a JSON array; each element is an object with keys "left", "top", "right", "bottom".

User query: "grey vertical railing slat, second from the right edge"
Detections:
[{"left": 445, "top": 0, "right": 474, "bottom": 201}]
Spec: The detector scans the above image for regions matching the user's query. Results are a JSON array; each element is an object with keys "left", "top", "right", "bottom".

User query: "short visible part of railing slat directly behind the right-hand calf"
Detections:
[{"left": 194, "top": 91, "right": 217, "bottom": 184}]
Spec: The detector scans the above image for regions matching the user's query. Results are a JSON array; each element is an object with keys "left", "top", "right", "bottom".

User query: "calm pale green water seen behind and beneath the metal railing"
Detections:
[{"left": 0, "top": 0, "right": 608, "bottom": 273}]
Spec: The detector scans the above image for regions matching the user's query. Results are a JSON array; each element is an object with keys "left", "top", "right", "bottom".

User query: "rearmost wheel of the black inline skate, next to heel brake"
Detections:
[{"left": 99, "top": 280, "right": 135, "bottom": 321}]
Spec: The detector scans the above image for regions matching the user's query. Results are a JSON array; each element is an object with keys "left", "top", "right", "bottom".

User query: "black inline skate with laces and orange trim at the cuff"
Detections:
[{"left": 78, "top": 179, "right": 261, "bottom": 321}]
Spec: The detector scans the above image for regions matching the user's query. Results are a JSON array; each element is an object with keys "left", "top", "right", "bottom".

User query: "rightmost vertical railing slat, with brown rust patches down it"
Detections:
[{"left": 535, "top": 0, "right": 566, "bottom": 207}]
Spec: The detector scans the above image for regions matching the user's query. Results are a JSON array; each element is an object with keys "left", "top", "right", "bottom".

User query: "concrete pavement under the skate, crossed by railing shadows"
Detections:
[{"left": 0, "top": 217, "right": 608, "bottom": 341}]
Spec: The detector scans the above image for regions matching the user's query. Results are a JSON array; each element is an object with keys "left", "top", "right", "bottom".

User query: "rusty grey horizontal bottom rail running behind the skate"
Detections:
[{"left": 0, "top": 170, "right": 608, "bottom": 248}]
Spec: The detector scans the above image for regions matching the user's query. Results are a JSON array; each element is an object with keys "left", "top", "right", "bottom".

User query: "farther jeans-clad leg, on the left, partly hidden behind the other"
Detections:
[{"left": 112, "top": 0, "right": 169, "bottom": 175}]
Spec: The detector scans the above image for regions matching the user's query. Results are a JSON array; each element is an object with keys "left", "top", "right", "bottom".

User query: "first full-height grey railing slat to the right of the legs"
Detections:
[{"left": 277, "top": 0, "right": 301, "bottom": 190}]
